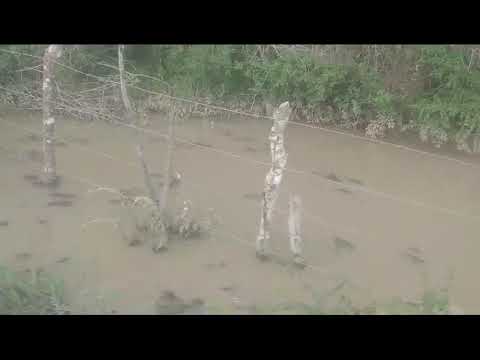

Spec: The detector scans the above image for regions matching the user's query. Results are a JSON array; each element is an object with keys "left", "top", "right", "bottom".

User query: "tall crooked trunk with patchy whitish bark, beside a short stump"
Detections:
[{"left": 256, "top": 102, "right": 292, "bottom": 259}]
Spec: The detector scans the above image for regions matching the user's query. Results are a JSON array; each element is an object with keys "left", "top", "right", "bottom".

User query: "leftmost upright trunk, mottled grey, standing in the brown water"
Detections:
[{"left": 42, "top": 45, "right": 62, "bottom": 185}]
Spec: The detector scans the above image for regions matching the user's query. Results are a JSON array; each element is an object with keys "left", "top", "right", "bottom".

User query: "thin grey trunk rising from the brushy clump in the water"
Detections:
[{"left": 153, "top": 105, "right": 177, "bottom": 252}]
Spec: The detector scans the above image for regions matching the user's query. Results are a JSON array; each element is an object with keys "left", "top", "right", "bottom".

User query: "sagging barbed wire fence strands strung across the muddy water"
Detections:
[{"left": 0, "top": 49, "right": 480, "bottom": 284}]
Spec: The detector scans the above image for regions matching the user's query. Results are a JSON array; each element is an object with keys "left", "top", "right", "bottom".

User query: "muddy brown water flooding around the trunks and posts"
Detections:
[{"left": 0, "top": 108, "right": 480, "bottom": 314}]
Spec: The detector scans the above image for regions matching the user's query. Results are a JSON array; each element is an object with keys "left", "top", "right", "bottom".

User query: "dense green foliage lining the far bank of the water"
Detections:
[{"left": 0, "top": 45, "right": 480, "bottom": 148}]
